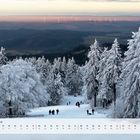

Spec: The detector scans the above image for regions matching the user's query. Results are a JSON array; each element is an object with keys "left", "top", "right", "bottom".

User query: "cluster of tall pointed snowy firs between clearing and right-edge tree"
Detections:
[{"left": 83, "top": 39, "right": 122, "bottom": 107}]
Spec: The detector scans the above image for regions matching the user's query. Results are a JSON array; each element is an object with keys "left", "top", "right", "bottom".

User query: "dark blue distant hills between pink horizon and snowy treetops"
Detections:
[{"left": 0, "top": 22, "right": 140, "bottom": 61}]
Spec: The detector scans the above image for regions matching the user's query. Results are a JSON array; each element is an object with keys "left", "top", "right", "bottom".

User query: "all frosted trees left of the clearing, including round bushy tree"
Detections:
[{"left": 0, "top": 47, "right": 82, "bottom": 116}]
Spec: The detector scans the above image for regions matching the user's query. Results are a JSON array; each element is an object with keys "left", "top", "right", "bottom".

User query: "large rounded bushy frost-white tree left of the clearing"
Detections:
[{"left": 0, "top": 59, "right": 49, "bottom": 116}]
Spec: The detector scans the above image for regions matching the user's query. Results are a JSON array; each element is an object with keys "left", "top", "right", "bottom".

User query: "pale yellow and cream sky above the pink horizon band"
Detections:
[{"left": 0, "top": 0, "right": 140, "bottom": 16}]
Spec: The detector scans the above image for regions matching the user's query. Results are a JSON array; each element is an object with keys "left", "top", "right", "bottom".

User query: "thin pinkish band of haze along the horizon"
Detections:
[{"left": 0, "top": 16, "right": 140, "bottom": 23}]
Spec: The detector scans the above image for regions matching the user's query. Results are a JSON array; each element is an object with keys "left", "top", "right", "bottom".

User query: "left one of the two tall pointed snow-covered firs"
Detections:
[{"left": 83, "top": 39, "right": 100, "bottom": 107}]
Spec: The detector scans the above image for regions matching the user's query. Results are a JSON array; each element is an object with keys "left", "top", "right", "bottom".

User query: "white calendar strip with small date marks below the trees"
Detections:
[{"left": 0, "top": 118, "right": 140, "bottom": 134}]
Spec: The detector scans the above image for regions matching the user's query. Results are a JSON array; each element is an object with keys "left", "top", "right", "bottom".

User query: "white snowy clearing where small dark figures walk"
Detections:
[{"left": 27, "top": 96, "right": 108, "bottom": 118}]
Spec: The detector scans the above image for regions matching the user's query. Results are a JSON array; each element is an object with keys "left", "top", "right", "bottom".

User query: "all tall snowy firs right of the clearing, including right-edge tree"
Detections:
[{"left": 83, "top": 29, "right": 140, "bottom": 118}]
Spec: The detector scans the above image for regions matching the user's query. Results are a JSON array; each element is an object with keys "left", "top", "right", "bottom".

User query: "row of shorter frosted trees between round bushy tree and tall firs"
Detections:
[{"left": 25, "top": 57, "right": 82, "bottom": 105}]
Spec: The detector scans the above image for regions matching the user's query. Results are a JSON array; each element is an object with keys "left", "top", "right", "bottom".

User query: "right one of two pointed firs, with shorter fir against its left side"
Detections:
[{"left": 98, "top": 39, "right": 122, "bottom": 107}]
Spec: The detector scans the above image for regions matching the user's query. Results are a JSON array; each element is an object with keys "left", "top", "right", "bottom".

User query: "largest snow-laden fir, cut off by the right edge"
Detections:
[{"left": 115, "top": 28, "right": 140, "bottom": 118}]
